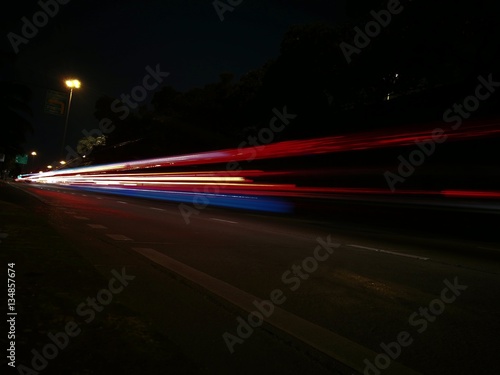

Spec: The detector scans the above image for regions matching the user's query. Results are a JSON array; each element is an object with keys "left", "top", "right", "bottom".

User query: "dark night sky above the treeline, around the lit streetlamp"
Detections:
[{"left": 1, "top": 0, "right": 345, "bottom": 167}]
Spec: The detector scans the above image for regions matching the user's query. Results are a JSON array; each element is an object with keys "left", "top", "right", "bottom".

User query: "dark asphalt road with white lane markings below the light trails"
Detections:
[{"left": 4, "top": 184, "right": 500, "bottom": 374}]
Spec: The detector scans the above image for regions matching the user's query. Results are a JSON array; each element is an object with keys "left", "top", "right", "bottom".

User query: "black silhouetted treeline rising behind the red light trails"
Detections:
[{"left": 0, "top": 0, "right": 500, "bottom": 167}]
